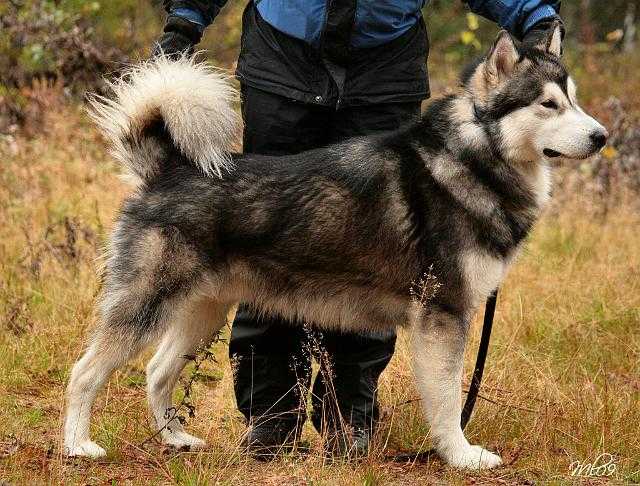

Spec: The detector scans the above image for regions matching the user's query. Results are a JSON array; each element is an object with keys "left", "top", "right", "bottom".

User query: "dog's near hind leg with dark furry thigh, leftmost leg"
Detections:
[{"left": 64, "top": 226, "right": 202, "bottom": 457}]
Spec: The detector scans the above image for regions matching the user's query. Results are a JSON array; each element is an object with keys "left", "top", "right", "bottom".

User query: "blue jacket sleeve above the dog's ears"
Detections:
[{"left": 463, "top": 0, "right": 561, "bottom": 39}]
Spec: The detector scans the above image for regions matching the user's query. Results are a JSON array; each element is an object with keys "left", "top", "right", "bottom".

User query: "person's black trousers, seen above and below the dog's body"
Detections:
[{"left": 229, "top": 85, "right": 420, "bottom": 431}]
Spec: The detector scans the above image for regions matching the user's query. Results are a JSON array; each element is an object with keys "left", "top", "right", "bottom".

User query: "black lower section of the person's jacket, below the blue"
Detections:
[{"left": 236, "top": 3, "right": 429, "bottom": 108}]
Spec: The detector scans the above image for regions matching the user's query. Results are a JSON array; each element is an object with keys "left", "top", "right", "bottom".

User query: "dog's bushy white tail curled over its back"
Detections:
[{"left": 89, "top": 55, "right": 240, "bottom": 184}]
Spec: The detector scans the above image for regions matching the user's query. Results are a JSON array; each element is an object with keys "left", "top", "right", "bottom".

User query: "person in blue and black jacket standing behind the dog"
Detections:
[{"left": 155, "top": 0, "right": 560, "bottom": 455}]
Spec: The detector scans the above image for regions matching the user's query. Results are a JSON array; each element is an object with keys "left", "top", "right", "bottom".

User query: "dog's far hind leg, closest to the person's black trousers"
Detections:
[{"left": 147, "top": 297, "right": 230, "bottom": 450}]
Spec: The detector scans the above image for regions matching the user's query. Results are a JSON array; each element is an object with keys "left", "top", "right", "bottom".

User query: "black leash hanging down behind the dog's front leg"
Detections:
[{"left": 389, "top": 289, "right": 498, "bottom": 462}]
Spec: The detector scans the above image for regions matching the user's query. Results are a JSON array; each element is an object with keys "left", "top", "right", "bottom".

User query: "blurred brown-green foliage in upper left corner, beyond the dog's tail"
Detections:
[{"left": 0, "top": 0, "right": 161, "bottom": 133}]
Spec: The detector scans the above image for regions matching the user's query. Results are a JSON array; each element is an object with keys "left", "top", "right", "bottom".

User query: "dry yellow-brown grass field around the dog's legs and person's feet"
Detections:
[{"left": 0, "top": 94, "right": 640, "bottom": 485}]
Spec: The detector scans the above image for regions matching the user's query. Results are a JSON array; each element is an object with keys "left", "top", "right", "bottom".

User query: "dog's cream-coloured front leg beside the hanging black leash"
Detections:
[{"left": 411, "top": 310, "right": 502, "bottom": 469}]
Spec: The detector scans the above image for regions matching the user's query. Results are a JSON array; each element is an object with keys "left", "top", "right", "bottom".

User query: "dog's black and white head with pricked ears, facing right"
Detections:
[{"left": 464, "top": 24, "right": 608, "bottom": 162}]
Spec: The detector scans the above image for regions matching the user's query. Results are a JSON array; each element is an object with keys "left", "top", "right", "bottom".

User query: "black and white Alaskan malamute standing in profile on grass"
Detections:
[{"left": 64, "top": 28, "right": 607, "bottom": 468}]
